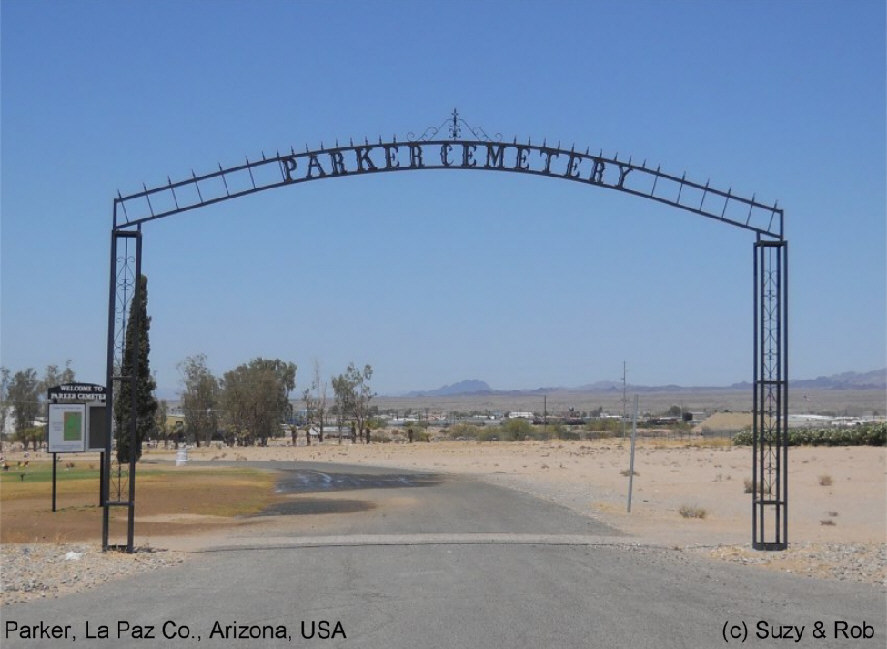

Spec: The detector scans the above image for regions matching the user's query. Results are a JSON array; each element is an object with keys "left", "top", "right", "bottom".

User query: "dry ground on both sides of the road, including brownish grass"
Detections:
[{"left": 0, "top": 439, "right": 887, "bottom": 601}]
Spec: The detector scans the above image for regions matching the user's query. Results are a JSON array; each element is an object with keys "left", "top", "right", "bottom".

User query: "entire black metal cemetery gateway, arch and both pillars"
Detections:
[{"left": 102, "top": 110, "right": 788, "bottom": 552}]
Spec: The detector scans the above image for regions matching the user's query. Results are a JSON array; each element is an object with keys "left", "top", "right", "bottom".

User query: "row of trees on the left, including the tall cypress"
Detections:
[{"left": 0, "top": 275, "right": 375, "bottom": 462}]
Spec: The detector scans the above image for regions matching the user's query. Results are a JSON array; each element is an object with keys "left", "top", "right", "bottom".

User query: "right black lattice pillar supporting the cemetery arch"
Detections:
[{"left": 752, "top": 237, "right": 788, "bottom": 550}]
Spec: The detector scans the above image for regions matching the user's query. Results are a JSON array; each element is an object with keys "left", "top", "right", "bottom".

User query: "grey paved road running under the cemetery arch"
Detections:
[{"left": 2, "top": 464, "right": 887, "bottom": 649}]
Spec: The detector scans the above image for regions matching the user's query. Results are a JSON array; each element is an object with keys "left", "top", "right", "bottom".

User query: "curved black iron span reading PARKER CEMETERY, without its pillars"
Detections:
[{"left": 114, "top": 120, "right": 784, "bottom": 239}]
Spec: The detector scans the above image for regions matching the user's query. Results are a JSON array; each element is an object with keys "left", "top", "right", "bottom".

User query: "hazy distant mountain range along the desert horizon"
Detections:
[{"left": 402, "top": 368, "right": 887, "bottom": 397}]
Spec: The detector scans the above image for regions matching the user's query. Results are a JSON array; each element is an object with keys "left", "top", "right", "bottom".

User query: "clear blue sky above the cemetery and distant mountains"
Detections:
[{"left": 0, "top": 0, "right": 887, "bottom": 393}]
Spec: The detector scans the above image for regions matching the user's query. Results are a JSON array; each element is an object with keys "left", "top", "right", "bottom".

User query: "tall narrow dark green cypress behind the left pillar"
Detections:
[{"left": 114, "top": 275, "right": 157, "bottom": 463}]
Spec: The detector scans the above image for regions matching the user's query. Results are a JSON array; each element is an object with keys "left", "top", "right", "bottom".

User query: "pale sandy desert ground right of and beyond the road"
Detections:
[{"left": 4, "top": 438, "right": 887, "bottom": 604}]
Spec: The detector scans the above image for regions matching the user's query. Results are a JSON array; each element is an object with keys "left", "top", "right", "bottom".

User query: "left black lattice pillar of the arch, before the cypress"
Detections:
[{"left": 101, "top": 224, "right": 142, "bottom": 552}]
